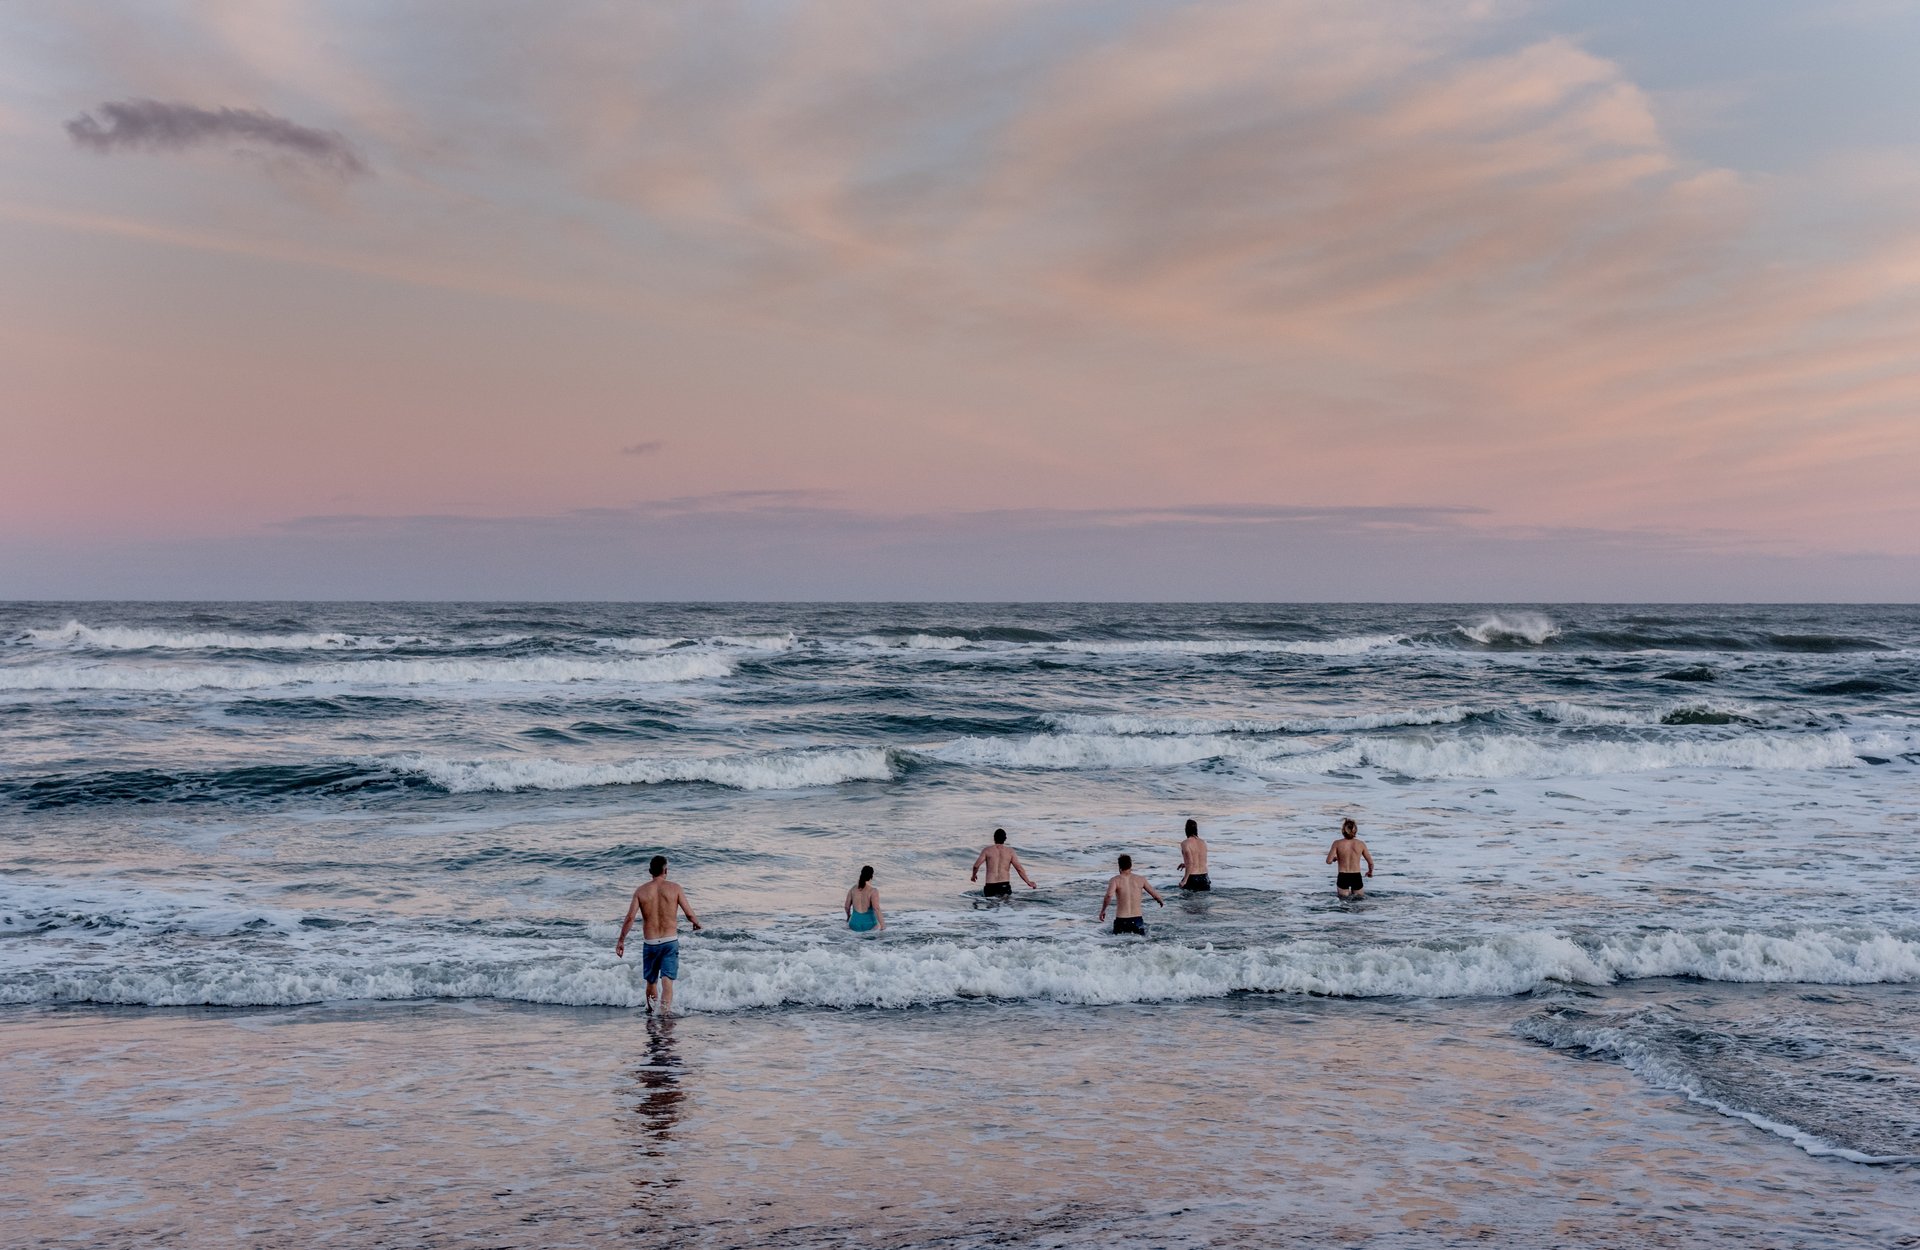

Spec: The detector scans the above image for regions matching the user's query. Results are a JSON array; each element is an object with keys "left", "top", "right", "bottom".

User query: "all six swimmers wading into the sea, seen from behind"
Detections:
[{"left": 612, "top": 820, "right": 1373, "bottom": 1012}]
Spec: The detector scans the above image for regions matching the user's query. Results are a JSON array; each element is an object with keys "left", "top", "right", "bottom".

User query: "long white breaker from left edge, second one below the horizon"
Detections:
[{"left": 0, "top": 653, "right": 733, "bottom": 693}]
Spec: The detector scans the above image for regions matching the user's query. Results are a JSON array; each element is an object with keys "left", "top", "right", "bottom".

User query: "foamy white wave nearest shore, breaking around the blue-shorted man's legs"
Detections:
[{"left": 0, "top": 916, "right": 1920, "bottom": 1012}]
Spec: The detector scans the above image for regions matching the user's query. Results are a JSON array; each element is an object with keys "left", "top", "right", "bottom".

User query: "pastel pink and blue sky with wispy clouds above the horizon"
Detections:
[{"left": 0, "top": 0, "right": 1920, "bottom": 603}]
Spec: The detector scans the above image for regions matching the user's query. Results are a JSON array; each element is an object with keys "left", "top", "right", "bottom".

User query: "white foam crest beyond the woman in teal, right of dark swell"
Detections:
[{"left": 391, "top": 747, "right": 893, "bottom": 793}]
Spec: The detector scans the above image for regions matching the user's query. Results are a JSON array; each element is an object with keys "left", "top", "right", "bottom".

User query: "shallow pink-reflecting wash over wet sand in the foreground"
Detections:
[{"left": 0, "top": 997, "right": 1920, "bottom": 1248}]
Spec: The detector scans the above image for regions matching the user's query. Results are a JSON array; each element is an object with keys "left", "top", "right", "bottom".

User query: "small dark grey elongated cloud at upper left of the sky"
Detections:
[{"left": 67, "top": 100, "right": 371, "bottom": 179}]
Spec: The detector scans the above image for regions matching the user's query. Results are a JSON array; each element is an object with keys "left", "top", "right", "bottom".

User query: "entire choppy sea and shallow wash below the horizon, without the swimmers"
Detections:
[{"left": 0, "top": 603, "right": 1920, "bottom": 1248}]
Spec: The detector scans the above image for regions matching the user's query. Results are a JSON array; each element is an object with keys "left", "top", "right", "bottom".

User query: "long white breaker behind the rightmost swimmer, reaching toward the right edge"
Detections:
[{"left": 1256, "top": 732, "right": 1914, "bottom": 780}]
